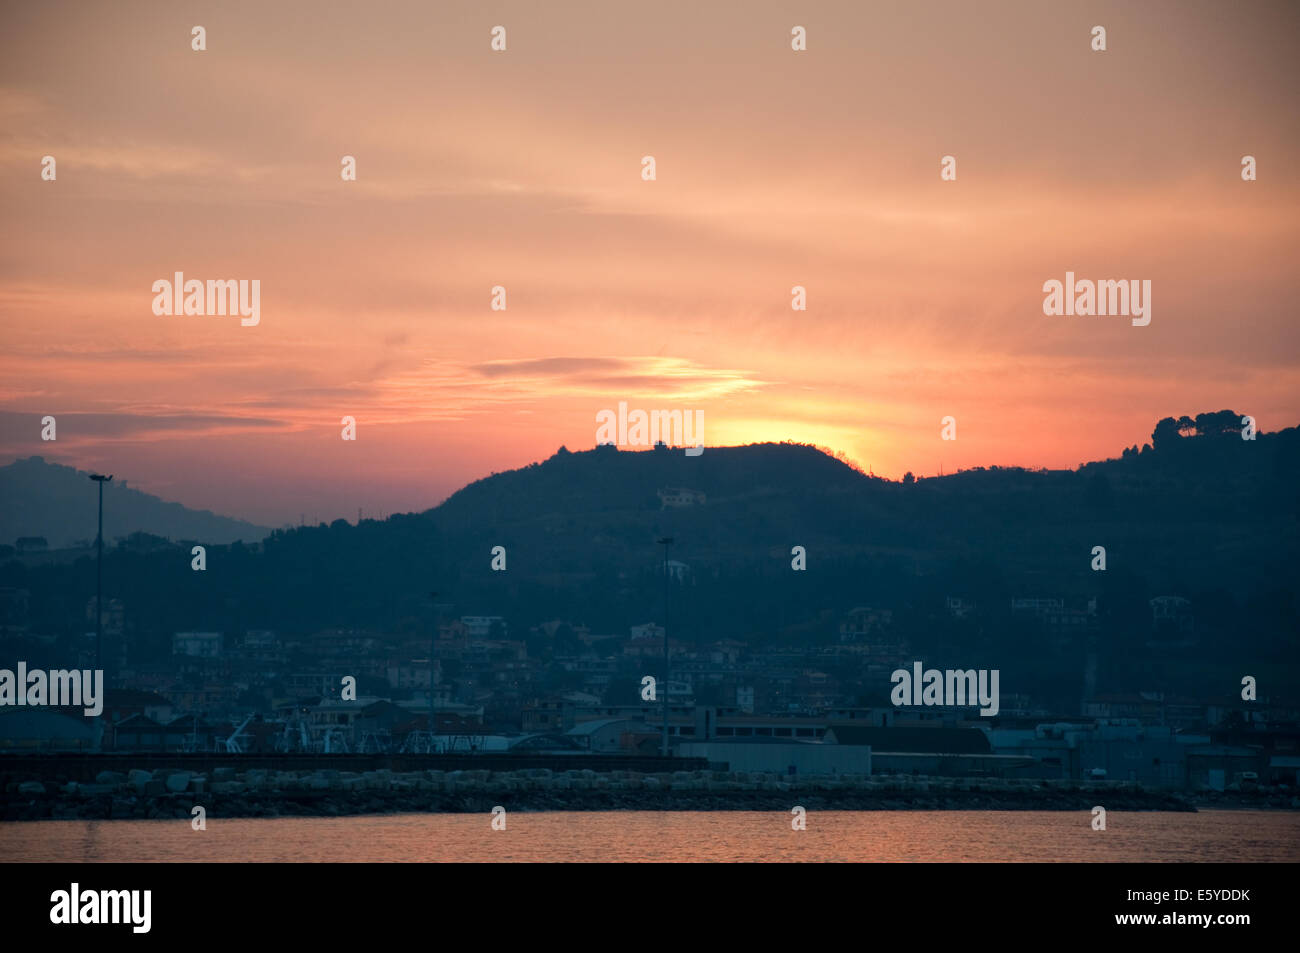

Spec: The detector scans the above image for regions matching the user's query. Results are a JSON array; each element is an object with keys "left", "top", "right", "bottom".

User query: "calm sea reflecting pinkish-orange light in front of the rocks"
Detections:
[{"left": 0, "top": 811, "right": 1300, "bottom": 863}]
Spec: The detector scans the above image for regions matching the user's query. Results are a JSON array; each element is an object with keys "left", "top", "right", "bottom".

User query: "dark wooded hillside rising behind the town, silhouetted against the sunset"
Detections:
[{"left": 0, "top": 429, "right": 1300, "bottom": 677}]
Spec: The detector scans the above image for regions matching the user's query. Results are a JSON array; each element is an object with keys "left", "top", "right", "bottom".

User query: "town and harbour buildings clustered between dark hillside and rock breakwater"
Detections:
[{"left": 0, "top": 590, "right": 1300, "bottom": 789}]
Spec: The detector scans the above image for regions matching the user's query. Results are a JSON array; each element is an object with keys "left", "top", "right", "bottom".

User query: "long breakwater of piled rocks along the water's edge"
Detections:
[{"left": 0, "top": 767, "right": 1279, "bottom": 820}]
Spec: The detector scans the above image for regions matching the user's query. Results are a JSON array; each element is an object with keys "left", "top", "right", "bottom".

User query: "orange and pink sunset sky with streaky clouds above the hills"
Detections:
[{"left": 0, "top": 0, "right": 1300, "bottom": 525}]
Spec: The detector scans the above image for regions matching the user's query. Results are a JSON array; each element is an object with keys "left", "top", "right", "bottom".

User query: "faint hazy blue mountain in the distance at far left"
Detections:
[{"left": 0, "top": 456, "right": 270, "bottom": 549}]
